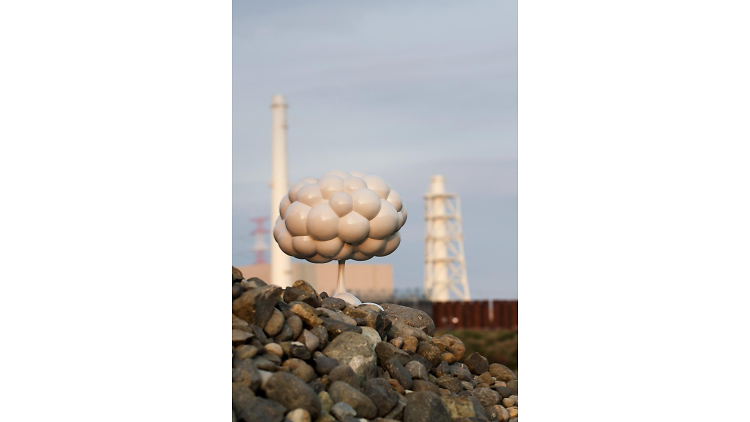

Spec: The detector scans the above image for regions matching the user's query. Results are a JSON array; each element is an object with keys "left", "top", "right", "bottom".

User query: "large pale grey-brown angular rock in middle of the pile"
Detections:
[{"left": 323, "top": 332, "right": 378, "bottom": 380}]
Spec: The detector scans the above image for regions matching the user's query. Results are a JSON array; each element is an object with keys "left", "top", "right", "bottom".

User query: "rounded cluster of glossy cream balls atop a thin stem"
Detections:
[{"left": 273, "top": 171, "right": 406, "bottom": 263}]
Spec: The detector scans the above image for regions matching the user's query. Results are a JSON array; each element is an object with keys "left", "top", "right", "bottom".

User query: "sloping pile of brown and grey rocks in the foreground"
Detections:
[{"left": 232, "top": 267, "right": 518, "bottom": 422}]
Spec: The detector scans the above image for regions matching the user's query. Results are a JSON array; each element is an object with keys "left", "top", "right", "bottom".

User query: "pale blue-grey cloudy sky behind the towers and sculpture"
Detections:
[{"left": 232, "top": 0, "right": 518, "bottom": 299}]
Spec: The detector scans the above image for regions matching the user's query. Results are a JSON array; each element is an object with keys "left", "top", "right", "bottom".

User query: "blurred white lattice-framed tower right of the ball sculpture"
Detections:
[{"left": 424, "top": 175, "right": 471, "bottom": 302}]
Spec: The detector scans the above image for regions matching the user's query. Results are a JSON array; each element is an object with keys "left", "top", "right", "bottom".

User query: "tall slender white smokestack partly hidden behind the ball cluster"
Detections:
[{"left": 271, "top": 95, "right": 292, "bottom": 287}]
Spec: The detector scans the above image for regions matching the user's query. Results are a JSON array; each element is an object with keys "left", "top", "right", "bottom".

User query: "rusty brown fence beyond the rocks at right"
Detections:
[{"left": 431, "top": 300, "right": 518, "bottom": 329}]
